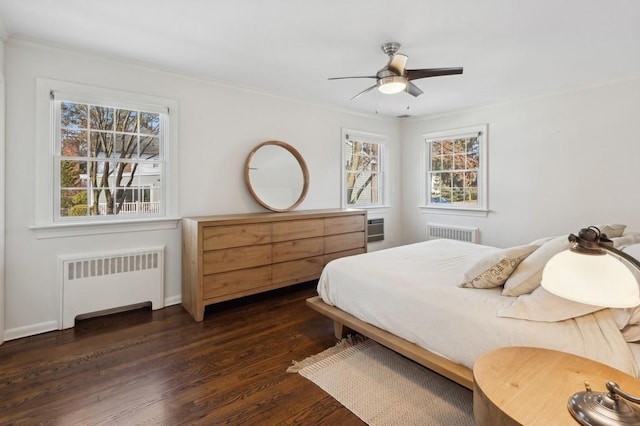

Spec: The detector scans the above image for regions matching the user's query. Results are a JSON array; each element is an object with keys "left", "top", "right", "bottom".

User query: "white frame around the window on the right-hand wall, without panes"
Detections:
[{"left": 421, "top": 124, "right": 489, "bottom": 216}]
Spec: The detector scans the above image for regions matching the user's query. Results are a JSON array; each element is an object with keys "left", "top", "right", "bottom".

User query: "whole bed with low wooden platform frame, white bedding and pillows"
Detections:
[{"left": 307, "top": 234, "right": 640, "bottom": 389}]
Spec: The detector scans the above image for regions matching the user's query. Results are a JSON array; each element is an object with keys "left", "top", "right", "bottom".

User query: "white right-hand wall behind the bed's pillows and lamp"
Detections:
[{"left": 402, "top": 79, "right": 640, "bottom": 247}]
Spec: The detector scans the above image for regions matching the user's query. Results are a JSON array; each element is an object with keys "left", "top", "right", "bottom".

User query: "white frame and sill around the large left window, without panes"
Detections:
[{"left": 31, "top": 78, "right": 179, "bottom": 238}]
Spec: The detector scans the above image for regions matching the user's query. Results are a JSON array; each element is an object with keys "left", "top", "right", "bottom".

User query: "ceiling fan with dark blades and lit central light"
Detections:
[{"left": 329, "top": 42, "right": 462, "bottom": 100}]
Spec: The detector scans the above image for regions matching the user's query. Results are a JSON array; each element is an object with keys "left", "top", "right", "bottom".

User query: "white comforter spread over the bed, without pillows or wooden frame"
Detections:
[{"left": 318, "top": 240, "right": 638, "bottom": 377}]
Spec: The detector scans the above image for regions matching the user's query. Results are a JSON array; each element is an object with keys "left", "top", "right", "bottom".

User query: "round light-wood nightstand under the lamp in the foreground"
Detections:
[{"left": 473, "top": 347, "right": 640, "bottom": 426}]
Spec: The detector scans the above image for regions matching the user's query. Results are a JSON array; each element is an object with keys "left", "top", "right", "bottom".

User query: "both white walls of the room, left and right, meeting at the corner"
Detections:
[{"left": 7, "top": 40, "right": 640, "bottom": 339}]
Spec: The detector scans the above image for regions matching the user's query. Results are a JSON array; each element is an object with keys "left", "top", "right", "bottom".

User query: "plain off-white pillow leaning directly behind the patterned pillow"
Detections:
[{"left": 502, "top": 235, "right": 571, "bottom": 296}]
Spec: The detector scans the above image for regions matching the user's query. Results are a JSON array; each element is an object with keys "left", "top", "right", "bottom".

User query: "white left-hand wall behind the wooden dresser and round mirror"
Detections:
[{"left": 5, "top": 40, "right": 401, "bottom": 339}]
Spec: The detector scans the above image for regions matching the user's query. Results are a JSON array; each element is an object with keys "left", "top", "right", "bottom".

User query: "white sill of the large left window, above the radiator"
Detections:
[{"left": 29, "top": 218, "right": 180, "bottom": 240}]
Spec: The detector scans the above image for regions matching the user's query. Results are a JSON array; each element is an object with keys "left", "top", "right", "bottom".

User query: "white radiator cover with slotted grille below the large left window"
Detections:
[{"left": 58, "top": 247, "right": 164, "bottom": 329}]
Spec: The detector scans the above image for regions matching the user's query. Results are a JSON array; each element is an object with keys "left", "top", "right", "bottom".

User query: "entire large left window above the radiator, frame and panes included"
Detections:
[{"left": 33, "top": 79, "right": 177, "bottom": 238}]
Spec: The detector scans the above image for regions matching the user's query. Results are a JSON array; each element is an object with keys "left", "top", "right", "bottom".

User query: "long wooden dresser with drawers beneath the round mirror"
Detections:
[{"left": 182, "top": 210, "right": 367, "bottom": 321}]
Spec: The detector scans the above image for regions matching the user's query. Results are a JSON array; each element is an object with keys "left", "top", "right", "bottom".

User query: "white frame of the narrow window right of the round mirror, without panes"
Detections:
[{"left": 340, "top": 128, "right": 389, "bottom": 209}]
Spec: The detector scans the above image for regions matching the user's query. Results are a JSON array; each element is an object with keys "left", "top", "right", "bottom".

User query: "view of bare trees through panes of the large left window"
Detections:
[{"left": 58, "top": 101, "right": 163, "bottom": 218}]
